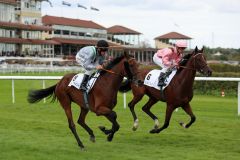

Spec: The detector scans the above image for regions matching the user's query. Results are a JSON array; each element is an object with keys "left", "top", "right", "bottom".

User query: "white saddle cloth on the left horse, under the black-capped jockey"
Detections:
[{"left": 68, "top": 72, "right": 100, "bottom": 93}]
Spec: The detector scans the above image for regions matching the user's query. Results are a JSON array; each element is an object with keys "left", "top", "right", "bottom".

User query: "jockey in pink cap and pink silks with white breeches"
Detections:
[{"left": 153, "top": 40, "right": 187, "bottom": 86}]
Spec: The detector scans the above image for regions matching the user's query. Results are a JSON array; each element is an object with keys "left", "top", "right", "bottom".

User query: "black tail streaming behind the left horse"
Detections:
[{"left": 28, "top": 84, "right": 57, "bottom": 103}]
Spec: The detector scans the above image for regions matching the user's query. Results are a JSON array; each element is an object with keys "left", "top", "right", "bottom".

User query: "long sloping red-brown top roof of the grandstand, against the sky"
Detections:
[{"left": 42, "top": 15, "right": 106, "bottom": 30}]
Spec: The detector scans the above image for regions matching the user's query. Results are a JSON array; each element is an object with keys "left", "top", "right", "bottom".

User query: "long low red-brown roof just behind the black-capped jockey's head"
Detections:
[{"left": 52, "top": 37, "right": 120, "bottom": 47}]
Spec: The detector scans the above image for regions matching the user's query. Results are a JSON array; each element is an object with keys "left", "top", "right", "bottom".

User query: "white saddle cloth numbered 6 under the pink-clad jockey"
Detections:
[{"left": 144, "top": 69, "right": 177, "bottom": 90}]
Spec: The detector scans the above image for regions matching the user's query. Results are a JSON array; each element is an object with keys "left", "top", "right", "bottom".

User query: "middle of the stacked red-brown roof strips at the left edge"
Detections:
[{"left": 0, "top": 21, "right": 52, "bottom": 31}]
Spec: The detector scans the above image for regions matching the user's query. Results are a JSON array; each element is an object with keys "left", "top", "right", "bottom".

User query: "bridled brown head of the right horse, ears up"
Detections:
[{"left": 190, "top": 47, "right": 212, "bottom": 76}]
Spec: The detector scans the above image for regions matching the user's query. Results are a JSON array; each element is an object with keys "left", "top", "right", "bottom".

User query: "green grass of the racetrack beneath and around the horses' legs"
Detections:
[{"left": 0, "top": 77, "right": 240, "bottom": 160}]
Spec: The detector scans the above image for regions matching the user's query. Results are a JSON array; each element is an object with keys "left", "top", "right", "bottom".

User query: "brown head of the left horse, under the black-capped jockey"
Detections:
[{"left": 124, "top": 52, "right": 143, "bottom": 85}]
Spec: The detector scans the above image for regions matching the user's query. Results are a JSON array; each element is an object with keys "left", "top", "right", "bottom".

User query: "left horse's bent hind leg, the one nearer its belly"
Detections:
[{"left": 78, "top": 108, "right": 95, "bottom": 142}]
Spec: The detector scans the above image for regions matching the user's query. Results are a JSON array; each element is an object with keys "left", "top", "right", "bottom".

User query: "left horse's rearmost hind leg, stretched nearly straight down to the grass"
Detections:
[{"left": 64, "top": 106, "right": 84, "bottom": 149}]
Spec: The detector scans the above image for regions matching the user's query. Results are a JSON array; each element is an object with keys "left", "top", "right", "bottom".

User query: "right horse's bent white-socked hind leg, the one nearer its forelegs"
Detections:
[{"left": 142, "top": 98, "right": 159, "bottom": 129}]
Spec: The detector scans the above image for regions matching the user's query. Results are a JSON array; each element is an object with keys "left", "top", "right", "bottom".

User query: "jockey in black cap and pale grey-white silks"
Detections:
[{"left": 76, "top": 40, "right": 109, "bottom": 91}]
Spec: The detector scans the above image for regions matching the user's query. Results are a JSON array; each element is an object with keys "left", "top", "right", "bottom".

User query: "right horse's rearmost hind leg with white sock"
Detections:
[{"left": 128, "top": 95, "right": 143, "bottom": 131}]
